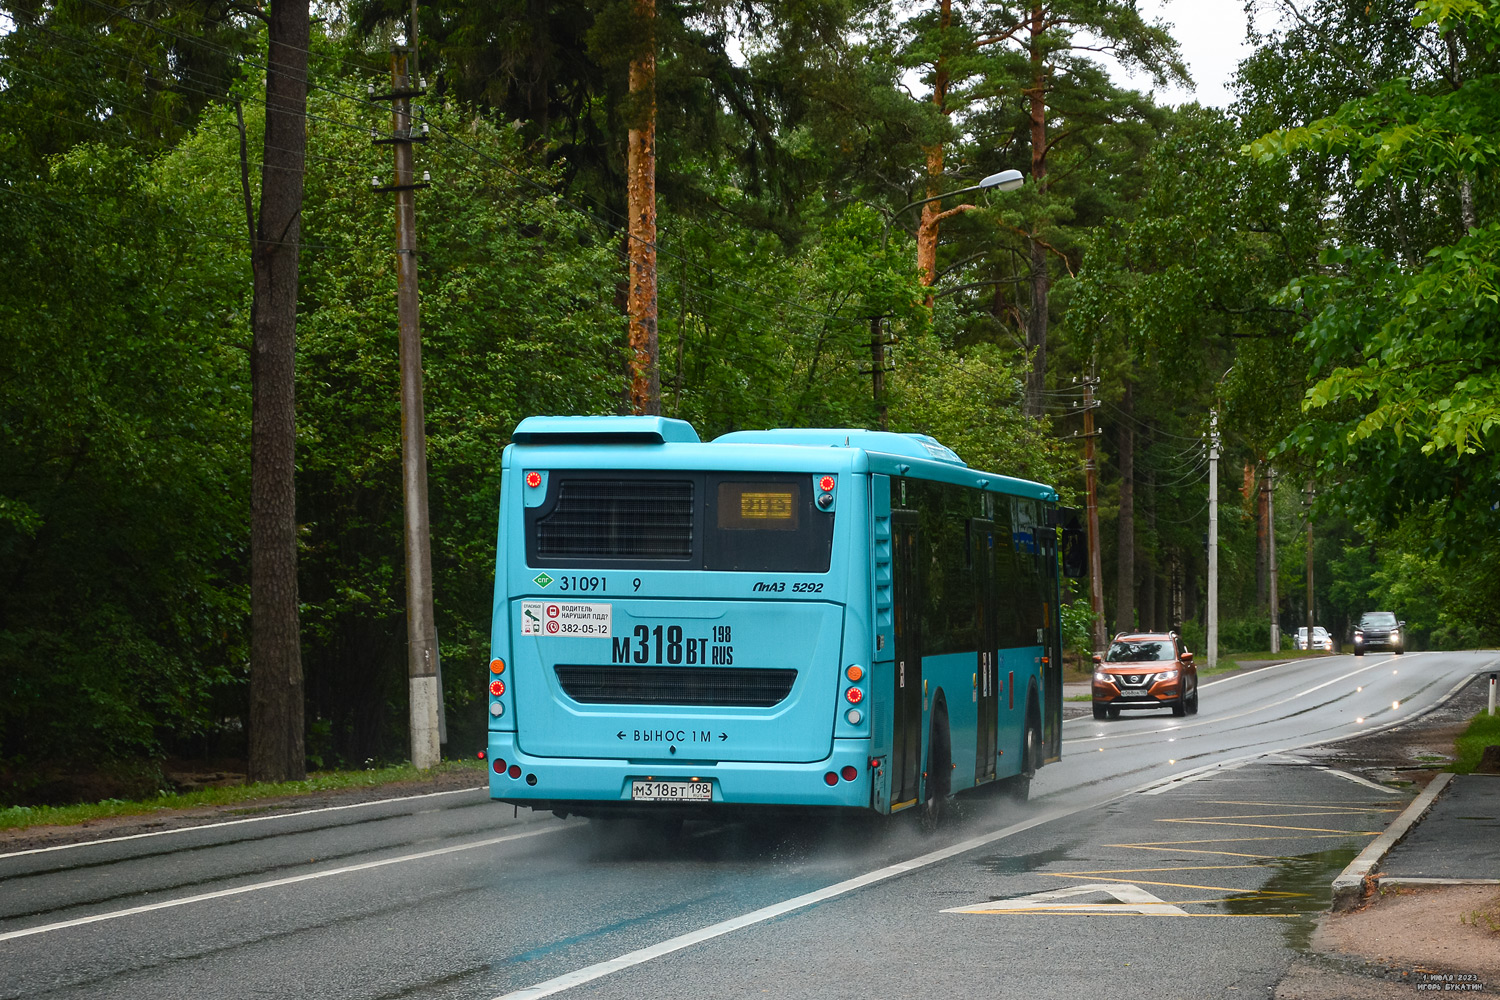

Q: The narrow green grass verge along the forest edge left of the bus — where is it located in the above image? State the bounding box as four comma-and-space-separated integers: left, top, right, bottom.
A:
0, 760, 485, 831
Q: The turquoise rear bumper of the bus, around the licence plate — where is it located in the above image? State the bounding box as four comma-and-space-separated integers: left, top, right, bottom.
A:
489, 732, 875, 814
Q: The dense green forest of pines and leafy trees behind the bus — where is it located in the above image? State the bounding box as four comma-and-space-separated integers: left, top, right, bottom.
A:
0, 0, 1500, 805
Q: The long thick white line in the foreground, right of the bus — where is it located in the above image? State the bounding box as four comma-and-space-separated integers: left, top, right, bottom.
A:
495, 804, 1097, 1000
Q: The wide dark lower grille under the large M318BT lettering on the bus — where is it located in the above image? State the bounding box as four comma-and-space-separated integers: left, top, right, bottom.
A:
557, 666, 797, 708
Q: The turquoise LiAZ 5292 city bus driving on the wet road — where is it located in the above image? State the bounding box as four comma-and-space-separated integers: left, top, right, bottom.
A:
488, 417, 1062, 819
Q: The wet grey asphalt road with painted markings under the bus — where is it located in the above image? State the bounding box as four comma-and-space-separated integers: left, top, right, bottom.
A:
0, 654, 1496, 1000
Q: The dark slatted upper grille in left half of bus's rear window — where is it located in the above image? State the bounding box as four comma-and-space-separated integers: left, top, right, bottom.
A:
536, 478, 693, 559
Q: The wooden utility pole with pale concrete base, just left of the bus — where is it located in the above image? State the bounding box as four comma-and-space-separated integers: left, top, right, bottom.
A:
374, 46, 443, 771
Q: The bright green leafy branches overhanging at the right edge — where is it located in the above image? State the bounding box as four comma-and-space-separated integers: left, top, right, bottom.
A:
1245, 0, 1500, 643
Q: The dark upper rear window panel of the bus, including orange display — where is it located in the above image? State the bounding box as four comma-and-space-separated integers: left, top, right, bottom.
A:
525, 471, 834, 573
